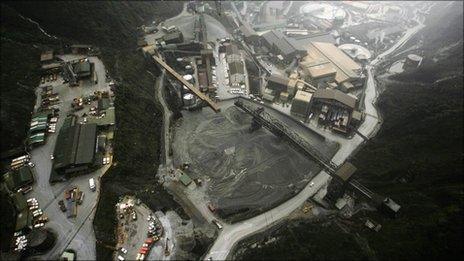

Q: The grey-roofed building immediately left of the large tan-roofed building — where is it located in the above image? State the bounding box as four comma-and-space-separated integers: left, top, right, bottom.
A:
261, 30, 307, 62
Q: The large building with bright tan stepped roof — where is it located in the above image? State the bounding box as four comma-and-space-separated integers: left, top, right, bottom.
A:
300, 42, 362, 91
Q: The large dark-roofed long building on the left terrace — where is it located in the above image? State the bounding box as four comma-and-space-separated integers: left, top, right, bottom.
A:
53, 117, 97, 175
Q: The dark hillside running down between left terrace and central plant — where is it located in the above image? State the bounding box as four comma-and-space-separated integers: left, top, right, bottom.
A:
2, 1, 187, 260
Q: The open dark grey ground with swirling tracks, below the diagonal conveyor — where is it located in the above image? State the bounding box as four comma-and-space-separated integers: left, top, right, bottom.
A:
173, 101, 337, 217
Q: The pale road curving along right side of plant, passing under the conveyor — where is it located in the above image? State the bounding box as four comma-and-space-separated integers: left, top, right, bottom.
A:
206, 5, 424, 260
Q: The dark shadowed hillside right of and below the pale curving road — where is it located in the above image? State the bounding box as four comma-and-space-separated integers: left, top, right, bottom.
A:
237, 3, 464, 260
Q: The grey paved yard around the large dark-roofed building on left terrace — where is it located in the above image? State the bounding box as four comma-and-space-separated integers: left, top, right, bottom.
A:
26, 55, 110, 260
